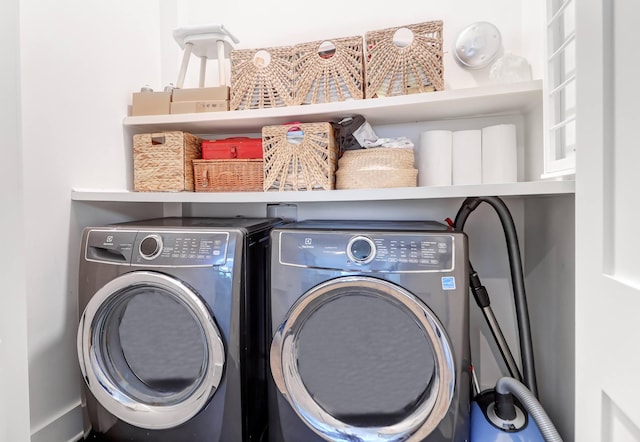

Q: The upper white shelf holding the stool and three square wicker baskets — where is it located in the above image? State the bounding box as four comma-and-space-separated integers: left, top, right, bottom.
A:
123, 80, 542, 134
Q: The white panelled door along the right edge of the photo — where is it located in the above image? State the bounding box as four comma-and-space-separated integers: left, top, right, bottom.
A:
575, 0, 640, 442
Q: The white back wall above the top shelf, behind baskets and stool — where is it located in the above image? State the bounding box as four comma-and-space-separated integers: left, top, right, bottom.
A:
159, 0, 544, 89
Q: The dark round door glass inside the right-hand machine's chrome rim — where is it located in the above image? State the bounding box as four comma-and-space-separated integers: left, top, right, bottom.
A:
297, 290, 435, 426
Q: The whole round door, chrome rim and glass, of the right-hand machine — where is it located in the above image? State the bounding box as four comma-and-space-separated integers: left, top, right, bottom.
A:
270, 276, 456, 441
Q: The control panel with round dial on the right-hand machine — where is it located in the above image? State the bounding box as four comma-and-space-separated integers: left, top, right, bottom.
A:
279, 231, 455, 272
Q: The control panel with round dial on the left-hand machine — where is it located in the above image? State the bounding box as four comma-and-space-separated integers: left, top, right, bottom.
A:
85, 229, 229, 267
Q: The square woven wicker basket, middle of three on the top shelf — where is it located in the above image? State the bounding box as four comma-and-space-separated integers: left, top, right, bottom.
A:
292, 36, 364, 104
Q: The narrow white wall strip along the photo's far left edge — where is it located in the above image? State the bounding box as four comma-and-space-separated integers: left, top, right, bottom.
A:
0, 0, 29, 442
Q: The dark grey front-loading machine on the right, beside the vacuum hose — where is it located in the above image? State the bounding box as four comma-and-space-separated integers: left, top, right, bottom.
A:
269, 220, 471, 442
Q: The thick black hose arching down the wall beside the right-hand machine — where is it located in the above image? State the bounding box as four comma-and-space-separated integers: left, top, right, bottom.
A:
454, 196, 538, 397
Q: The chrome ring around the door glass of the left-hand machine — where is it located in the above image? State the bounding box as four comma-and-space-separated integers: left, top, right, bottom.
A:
77, 271, 225, 429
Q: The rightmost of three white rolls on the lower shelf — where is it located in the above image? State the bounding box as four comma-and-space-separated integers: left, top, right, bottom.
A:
482, 124, 518, 184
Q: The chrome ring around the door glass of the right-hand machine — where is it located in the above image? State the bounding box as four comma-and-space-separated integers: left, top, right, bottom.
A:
270, 276, 455, 441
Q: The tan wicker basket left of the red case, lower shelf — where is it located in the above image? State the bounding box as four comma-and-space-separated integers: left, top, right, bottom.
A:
133, 132, 202, 192
